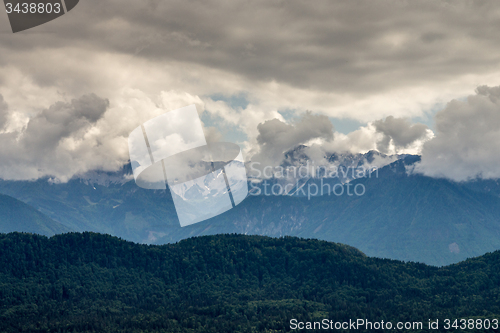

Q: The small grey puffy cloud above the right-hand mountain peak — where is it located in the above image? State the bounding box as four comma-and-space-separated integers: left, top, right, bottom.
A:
373, 116, 428, 153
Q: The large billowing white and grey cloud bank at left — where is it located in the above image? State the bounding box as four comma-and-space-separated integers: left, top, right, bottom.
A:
0, 89, 220, 182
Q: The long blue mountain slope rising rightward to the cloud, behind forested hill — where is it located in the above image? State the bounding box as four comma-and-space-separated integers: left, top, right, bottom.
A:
160, 156, 500, 265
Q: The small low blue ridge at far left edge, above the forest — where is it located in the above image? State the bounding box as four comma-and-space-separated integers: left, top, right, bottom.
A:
0, 194, 71, 236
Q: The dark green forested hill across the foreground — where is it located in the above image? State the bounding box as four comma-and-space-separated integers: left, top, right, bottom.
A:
0, 233, 500, 332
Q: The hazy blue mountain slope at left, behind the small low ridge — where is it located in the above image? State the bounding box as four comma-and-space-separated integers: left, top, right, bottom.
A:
0, 165, 180, 243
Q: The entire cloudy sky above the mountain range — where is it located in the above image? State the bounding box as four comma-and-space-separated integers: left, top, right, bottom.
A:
0, 0, 500, 181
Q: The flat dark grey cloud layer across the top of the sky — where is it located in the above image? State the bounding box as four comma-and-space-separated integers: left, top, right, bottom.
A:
0, 0, 500, 94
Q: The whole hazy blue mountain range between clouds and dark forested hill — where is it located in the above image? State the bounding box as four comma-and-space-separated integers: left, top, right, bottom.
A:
0, 156, 500, 265
